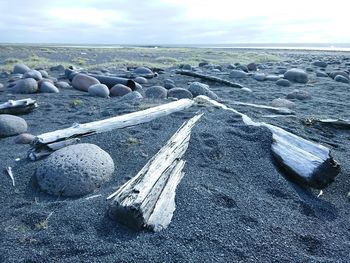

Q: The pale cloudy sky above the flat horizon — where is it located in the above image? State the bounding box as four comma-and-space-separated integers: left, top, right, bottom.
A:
0, 0, 350, 44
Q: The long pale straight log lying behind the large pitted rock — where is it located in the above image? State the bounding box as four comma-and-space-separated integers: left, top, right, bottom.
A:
28, 99, 194, 161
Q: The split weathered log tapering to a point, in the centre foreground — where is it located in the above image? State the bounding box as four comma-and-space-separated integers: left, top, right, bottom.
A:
107, 114, 203, 231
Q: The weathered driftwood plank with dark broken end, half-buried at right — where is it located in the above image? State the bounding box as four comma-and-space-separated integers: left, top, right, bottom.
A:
196, 96, 340, 189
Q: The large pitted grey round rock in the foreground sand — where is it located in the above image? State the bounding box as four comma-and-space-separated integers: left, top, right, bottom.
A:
36, 143, 114, 196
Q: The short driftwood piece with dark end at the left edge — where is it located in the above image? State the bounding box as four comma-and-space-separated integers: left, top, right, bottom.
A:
0, 99, 38, 114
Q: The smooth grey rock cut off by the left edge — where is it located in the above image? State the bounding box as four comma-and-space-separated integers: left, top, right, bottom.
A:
0, 114, 28, 138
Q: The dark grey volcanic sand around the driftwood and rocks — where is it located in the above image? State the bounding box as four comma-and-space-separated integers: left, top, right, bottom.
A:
0, 46, 350, 262
